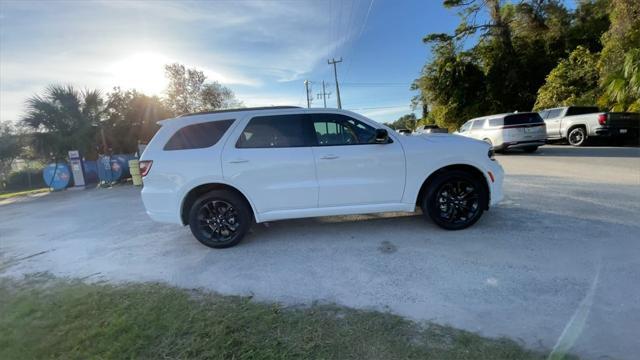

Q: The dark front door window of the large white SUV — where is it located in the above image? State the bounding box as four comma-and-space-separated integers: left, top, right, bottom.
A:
311, 114, 376, 146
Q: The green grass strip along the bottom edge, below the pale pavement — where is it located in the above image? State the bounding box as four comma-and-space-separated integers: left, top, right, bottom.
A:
0, 278, 544, 359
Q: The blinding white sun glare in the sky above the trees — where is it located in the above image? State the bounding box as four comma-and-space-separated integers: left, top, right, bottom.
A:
110, 52, 170, 95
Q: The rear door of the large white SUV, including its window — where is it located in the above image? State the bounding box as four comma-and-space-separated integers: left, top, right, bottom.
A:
222, 114, 318, 213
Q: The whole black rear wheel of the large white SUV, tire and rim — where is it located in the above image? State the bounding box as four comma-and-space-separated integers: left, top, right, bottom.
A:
189, 190, 252, 249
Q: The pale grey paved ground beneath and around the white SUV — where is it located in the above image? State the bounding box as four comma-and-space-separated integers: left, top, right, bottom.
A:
0, 146, 640, 359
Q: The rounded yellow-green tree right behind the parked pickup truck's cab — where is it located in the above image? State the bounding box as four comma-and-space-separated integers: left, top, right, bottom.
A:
534, 46, 598, 110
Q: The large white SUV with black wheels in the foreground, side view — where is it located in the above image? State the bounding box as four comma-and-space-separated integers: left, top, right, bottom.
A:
140, 107, 503, 248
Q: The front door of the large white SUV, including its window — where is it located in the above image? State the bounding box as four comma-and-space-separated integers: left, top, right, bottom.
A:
311, 113, 405, 207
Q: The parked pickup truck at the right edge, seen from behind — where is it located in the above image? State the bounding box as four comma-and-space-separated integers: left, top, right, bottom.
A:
540, 106, 640, 146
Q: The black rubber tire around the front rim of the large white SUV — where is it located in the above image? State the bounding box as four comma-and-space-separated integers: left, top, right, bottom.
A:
421, 170, 489, 230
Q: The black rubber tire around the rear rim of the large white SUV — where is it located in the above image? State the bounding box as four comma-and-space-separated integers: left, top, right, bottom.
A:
189, 190, 252, 249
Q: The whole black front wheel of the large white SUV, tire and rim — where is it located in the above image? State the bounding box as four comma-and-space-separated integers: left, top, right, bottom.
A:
421, 170, 489, 230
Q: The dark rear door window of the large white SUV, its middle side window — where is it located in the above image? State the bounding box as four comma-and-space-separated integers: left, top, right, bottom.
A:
236, 114, 310, 148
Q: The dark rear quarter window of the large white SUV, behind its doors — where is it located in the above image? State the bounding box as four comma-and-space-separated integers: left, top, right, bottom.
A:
164, 120, 233, 150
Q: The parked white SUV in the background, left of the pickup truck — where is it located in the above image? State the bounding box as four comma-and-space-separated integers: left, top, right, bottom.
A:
457, 112, 547, 152
